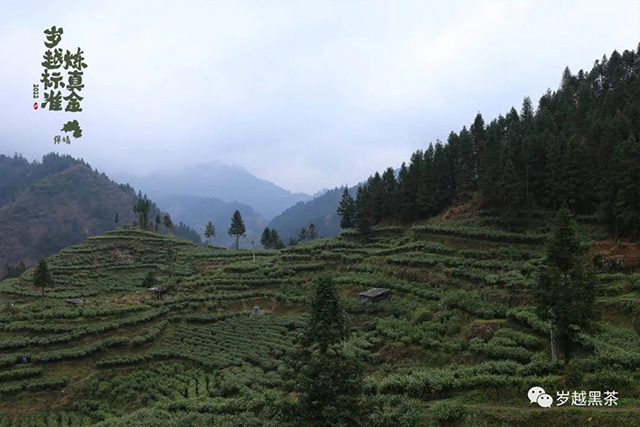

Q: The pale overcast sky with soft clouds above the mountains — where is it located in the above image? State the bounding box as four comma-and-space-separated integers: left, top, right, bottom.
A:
0, 0, 640, 193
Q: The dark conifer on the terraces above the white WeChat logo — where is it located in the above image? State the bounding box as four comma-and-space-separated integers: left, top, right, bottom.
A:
536, 208, 596, 362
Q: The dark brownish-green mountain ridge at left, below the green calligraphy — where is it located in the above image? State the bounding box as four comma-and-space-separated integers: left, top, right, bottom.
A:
0, 153, 199, 275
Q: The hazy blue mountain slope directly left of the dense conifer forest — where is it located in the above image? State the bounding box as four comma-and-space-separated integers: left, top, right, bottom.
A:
269, 186, 358, 243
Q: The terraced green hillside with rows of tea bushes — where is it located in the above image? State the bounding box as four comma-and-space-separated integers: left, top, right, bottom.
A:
0, 216, 640, 426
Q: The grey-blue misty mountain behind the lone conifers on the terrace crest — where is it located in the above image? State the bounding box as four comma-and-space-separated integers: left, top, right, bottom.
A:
156, 195, 267, 248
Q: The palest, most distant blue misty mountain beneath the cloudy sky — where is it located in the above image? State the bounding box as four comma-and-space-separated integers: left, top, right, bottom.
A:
121, 163, 311, 219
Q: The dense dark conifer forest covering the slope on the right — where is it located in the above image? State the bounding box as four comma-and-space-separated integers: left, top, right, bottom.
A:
350, 46, 640, 240
